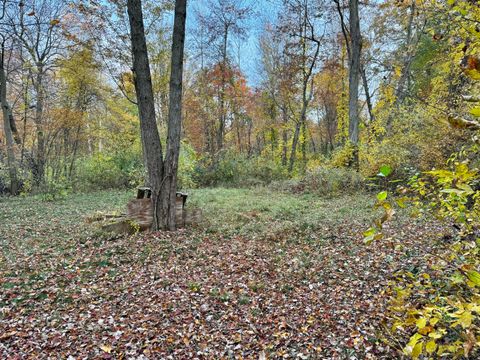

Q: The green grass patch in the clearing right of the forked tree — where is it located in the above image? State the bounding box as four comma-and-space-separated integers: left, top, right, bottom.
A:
188, 188, 373, 236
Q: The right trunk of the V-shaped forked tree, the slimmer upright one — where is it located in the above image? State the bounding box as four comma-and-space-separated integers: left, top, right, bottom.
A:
161, 0, 187, 230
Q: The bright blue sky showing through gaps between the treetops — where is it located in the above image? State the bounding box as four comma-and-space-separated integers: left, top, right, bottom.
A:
186, 0, 281, 86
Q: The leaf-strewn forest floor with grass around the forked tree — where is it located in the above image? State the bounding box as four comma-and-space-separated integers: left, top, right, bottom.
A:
0, 189, 448, 359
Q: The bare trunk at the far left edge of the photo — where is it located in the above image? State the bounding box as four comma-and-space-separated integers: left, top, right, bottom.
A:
0, 47, 19, 195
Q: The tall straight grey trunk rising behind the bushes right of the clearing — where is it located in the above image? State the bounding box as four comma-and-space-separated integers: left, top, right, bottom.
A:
348, 0, 362, 170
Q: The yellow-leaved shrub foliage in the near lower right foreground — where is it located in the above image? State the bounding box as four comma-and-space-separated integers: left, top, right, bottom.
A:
364, 155, 480, 359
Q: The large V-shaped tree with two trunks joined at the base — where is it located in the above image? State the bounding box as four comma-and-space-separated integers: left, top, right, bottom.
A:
127, 0, 186, 230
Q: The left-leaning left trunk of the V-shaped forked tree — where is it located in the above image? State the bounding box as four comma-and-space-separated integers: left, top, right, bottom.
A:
127, 0, 166, 230
